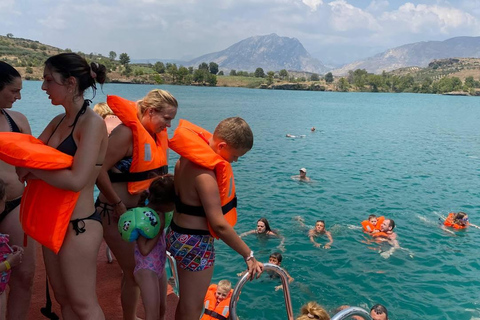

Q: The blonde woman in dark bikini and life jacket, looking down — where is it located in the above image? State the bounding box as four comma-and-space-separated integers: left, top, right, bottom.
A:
95, 89, 178, 320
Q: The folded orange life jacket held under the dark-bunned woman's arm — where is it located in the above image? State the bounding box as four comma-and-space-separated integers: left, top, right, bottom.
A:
0, 132, 80, 253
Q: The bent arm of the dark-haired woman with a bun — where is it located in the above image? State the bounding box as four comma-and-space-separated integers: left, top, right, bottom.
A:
20, 114, 106, 192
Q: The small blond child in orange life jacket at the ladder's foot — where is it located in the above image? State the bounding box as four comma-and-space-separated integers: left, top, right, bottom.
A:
200, 280, 233, 320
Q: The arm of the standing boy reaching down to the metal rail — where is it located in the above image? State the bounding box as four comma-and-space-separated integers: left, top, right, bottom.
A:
195, 170, 263, 280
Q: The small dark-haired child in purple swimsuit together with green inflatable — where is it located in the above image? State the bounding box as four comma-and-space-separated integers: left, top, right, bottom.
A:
118, 174, 175, 319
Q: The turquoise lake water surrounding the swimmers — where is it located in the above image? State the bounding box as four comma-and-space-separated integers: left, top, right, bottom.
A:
14, 81, 480, 320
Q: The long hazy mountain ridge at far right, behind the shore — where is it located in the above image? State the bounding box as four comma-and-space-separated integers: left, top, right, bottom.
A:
332, 37, 480, 76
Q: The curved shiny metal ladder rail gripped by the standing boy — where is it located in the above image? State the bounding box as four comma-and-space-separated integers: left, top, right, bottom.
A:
229, 263, 292, 320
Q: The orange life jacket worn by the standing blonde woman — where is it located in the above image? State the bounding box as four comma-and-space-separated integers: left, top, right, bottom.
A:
107, 96, 168, 194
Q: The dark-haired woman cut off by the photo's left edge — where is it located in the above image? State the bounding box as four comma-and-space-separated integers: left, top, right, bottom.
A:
0, 61, 36, 320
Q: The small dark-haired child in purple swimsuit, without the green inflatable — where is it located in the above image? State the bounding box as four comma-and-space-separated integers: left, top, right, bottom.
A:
133, 174, 175, 320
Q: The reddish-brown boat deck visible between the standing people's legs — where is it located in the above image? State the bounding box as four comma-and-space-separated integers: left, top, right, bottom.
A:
28, 243, 178, 320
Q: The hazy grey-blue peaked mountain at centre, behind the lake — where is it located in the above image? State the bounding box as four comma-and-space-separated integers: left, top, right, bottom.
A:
188, 33, 327, 74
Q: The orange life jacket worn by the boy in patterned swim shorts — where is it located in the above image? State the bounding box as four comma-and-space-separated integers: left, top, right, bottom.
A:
168, 119, 237, 239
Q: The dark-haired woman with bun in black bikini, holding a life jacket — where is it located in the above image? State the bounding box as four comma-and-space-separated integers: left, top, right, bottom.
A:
19, 53, 108, 319
